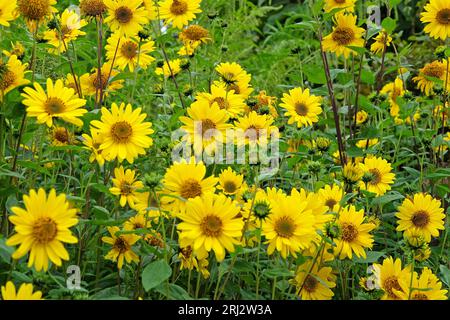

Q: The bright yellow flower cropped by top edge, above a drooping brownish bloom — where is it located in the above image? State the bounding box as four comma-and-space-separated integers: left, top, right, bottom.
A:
159, 0, 202, 29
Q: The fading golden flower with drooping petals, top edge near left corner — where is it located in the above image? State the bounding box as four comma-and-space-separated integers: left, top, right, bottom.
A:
17, 0, 58, 32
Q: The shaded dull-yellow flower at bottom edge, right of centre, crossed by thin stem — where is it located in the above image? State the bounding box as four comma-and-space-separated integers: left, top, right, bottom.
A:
293, 260, 336, 300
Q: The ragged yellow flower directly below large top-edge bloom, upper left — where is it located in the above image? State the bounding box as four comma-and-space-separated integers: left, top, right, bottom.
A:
105, 32, 155, 72
